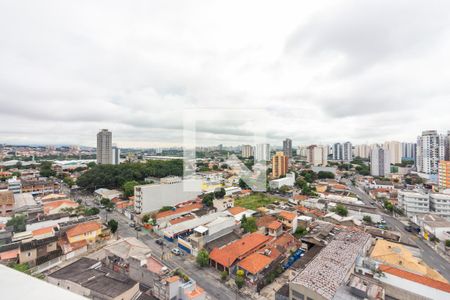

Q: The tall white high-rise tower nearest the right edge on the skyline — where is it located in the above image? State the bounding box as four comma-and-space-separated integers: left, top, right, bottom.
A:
416, 130, 446, 174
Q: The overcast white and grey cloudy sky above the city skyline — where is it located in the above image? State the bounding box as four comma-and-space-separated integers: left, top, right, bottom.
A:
0, 0, 450, 147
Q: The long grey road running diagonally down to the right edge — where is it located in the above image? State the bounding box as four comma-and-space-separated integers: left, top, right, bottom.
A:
348, 184, 450, 282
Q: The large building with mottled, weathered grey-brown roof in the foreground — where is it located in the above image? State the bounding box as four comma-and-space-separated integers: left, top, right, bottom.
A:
289, 231, 371, 300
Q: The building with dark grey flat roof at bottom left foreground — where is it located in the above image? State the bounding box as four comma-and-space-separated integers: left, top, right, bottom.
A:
47, 257, 139, 300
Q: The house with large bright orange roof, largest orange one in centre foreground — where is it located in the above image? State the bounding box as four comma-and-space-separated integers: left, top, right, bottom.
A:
209, 232, 272, 271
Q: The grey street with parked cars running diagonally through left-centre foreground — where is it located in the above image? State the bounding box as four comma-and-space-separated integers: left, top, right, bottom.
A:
101, 210, 244, 299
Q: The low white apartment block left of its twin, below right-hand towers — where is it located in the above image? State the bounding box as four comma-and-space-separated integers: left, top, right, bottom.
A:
398, 191, 430, 216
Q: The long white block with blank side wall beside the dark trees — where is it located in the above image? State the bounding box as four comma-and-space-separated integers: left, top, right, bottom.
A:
134, 179, 201, 214
